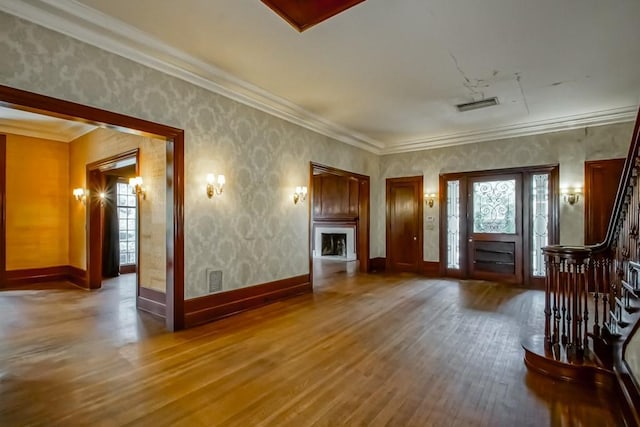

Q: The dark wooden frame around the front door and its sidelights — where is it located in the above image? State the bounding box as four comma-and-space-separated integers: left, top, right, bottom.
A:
439, 163, 560, 288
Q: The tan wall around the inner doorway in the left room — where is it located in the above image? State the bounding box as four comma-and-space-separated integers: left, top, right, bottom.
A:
69, 128, 166, 292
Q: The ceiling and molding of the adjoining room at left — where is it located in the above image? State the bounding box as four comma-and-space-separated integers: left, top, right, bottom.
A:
0, 106, 97, 142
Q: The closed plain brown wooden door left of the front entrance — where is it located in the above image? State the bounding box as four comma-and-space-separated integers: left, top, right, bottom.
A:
386, 176, 423, 272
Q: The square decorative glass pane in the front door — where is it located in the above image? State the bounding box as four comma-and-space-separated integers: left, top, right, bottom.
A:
473, 179, 516, 234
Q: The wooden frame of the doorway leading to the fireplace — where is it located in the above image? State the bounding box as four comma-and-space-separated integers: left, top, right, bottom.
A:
307, 162, 371, 285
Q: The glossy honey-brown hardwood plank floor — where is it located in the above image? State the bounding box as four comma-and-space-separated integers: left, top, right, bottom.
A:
0, 271, 623, 426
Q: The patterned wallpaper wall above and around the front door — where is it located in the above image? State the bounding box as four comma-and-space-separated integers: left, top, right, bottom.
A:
378, 123, 633, 261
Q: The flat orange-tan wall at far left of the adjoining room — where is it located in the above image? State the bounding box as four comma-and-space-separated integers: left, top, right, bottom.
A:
6, 135, 71, 270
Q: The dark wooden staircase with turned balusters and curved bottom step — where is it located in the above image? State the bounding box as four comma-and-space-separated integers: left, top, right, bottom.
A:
522, 112, 640, 425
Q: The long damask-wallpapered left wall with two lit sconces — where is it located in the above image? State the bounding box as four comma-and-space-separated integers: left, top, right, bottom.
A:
0, 13, 383, 298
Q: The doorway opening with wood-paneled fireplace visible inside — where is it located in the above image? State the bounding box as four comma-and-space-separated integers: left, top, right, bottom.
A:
309, 163, 370, 284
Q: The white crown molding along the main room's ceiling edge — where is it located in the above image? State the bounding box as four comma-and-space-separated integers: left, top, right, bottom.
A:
0, 0, 637, 155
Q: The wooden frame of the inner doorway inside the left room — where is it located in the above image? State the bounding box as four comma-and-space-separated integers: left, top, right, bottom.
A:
85, 148, 140, 290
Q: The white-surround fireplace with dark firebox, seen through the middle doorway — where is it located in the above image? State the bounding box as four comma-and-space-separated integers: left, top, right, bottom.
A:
313, 224, 357, 261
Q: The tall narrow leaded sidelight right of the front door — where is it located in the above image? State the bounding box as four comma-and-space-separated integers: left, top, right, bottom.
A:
531, 174, 549, 277
